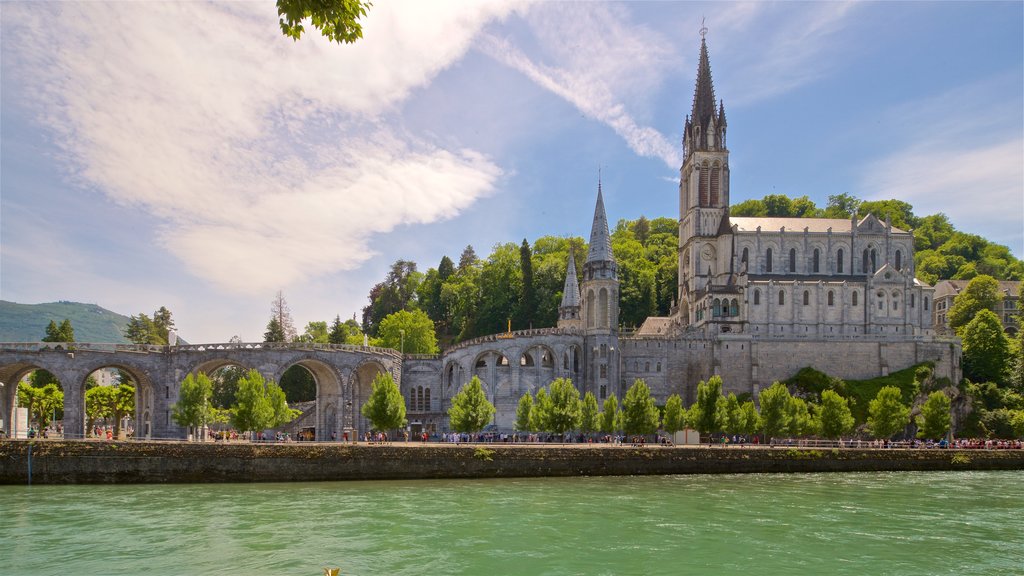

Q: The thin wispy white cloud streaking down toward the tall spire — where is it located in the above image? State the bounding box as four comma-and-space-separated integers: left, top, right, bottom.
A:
479, 3, 679, 168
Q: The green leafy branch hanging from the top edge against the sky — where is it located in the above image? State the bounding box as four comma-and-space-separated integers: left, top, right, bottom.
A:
278, 0, 373, 44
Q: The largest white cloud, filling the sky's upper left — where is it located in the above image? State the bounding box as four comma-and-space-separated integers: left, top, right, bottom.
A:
4, 2, 510, 293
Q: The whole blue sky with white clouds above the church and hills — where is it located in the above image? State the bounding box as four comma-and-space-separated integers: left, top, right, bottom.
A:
0, 0, 1024, 343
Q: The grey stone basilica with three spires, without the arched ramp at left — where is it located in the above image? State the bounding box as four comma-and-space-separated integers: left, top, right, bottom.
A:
401, 32, 961, 431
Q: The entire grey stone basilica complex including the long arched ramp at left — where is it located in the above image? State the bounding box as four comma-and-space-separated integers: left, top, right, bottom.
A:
0, 39, 961, 440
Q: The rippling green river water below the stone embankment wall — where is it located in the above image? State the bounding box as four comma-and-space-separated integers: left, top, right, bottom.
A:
0, 471, 1024, 576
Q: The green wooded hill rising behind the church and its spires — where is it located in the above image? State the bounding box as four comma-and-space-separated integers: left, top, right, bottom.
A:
362, 194, 1024, 347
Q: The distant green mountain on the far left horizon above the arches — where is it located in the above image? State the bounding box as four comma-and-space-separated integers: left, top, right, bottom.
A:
0, 300, 129, 344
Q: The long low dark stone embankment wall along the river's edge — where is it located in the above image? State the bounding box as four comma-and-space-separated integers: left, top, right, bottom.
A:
0, 441, 1024, 485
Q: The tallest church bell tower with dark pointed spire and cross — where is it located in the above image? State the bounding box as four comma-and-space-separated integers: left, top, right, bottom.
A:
679, 29, 732, 324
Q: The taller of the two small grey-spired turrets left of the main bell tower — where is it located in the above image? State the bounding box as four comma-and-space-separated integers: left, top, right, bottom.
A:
582, 180, 621, 402
